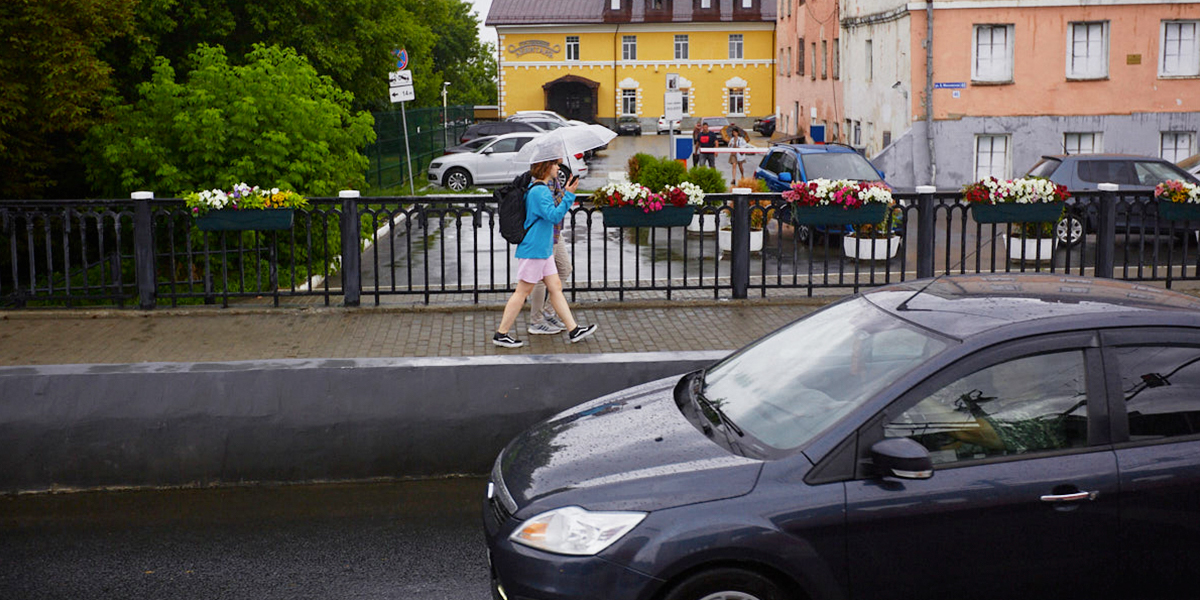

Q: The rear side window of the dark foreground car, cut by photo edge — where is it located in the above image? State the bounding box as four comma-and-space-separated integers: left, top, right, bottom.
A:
1115, 346, 1200, 440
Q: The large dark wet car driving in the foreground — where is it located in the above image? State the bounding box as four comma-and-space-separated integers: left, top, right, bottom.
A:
484, 274, 1200, 600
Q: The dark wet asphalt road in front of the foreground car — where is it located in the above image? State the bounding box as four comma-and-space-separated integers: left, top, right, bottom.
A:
0, 478, 491, 600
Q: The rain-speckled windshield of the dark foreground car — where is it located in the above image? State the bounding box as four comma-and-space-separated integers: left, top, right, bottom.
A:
704, 298, 947, 450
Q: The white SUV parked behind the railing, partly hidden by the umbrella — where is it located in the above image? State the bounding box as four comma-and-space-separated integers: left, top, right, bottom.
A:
428, 132, 588, 192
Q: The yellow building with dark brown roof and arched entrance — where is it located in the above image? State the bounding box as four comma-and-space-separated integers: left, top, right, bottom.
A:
486, 0, 775, 131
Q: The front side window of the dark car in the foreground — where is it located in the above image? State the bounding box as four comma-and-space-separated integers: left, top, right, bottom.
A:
884, 350, 1087, 464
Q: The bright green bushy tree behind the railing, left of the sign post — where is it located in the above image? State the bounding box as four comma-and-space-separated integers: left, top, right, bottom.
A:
88, 44, 374, 197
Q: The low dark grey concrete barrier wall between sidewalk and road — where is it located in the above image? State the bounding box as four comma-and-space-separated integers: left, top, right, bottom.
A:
0, 352, 725, 492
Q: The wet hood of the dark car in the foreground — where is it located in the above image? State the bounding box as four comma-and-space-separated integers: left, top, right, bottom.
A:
498, 378, 762, 515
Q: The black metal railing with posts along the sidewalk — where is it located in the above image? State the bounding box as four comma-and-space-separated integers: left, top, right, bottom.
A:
0, 187, 1200, 308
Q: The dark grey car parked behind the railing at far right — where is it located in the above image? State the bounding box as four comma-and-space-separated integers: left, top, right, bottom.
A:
1026, 154, 1200, 244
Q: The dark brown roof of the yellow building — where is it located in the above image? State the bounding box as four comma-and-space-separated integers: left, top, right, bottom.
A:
484, 0, 776, 26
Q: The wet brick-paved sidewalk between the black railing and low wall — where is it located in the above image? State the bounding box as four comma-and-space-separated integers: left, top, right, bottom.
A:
0, 298, 836, 366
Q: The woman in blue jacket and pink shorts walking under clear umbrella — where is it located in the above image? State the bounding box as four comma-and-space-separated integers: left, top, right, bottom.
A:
492, 158, 596, 348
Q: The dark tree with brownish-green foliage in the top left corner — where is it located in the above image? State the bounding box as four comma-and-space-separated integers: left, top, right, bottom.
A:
0, 0, 134, 198
